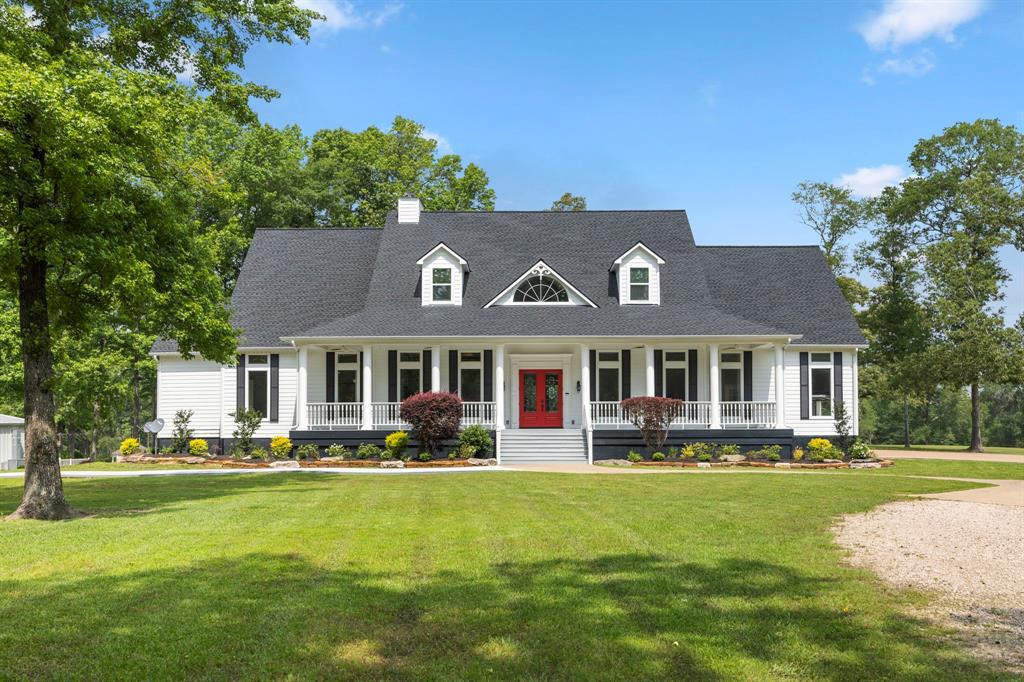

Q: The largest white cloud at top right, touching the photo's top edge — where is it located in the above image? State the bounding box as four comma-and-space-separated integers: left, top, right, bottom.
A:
858, 0, 985, 50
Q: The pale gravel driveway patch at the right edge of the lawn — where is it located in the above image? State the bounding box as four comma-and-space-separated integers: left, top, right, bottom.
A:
836, 500, 1024, 672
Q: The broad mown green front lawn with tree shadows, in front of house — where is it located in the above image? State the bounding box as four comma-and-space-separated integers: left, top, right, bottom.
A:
0, 472, 1010, 680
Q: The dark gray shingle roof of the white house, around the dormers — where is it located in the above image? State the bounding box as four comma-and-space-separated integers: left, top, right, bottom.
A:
155, 211, 864, 350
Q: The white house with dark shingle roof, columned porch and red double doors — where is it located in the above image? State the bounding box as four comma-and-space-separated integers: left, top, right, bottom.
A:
153, 199, 865, 462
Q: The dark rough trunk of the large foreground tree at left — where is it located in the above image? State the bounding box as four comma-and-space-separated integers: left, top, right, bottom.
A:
7, 243, 80, 520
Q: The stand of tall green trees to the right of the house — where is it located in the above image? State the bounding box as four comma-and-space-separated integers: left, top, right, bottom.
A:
793, 119, 1024, 452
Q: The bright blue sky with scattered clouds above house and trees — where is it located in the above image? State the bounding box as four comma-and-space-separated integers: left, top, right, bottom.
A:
247, 0, 1024, 318
